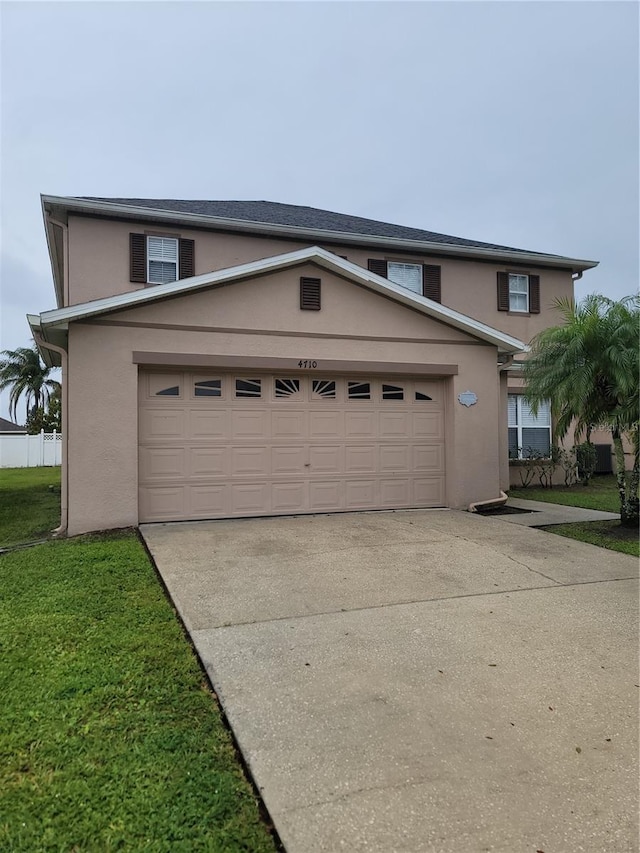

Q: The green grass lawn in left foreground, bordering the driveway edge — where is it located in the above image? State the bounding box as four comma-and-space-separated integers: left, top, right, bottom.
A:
0, 469, 277, 853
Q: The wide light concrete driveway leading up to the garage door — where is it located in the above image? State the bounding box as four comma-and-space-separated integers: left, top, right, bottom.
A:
141, 511, 640, 853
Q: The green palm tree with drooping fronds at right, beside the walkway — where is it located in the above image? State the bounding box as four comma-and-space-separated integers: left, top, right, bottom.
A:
523, 294, 640, 526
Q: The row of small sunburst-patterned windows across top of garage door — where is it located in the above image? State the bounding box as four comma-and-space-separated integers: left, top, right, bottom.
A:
155, 377, 433, 402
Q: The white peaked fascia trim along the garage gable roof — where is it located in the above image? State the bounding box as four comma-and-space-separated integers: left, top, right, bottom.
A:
40, 246, 526, 352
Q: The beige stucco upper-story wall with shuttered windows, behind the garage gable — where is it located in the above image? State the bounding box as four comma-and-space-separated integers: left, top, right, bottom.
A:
69, 216, 573, 343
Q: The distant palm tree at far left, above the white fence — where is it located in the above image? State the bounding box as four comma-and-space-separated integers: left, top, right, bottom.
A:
0, 344, 60, 418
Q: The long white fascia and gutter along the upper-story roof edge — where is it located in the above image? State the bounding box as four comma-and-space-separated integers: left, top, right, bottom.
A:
42, 195, 599, 271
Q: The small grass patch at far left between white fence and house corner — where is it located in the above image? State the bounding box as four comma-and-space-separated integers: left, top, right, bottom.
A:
0, 466, 60, 548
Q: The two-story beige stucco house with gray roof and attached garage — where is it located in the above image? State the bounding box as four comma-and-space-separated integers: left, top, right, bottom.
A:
29, 196, 595, 534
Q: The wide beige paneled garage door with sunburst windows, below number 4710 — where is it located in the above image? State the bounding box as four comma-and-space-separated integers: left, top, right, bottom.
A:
139, 371, 445, 521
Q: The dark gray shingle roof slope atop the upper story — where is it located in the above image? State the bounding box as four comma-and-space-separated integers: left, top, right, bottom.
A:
81, 196, 555, 257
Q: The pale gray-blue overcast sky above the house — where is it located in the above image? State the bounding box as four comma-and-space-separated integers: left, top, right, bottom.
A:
0, 0, 639, 417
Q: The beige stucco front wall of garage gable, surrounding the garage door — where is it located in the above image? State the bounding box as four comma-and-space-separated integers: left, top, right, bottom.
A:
68, 265, 502, 535
